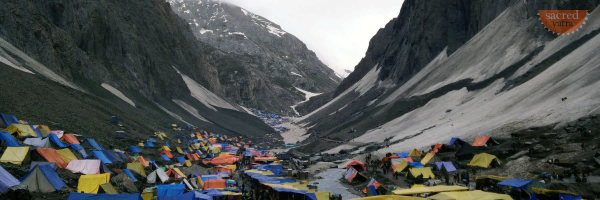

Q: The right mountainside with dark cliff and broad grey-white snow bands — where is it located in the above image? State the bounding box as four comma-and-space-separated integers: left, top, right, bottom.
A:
296, 0, 600, 153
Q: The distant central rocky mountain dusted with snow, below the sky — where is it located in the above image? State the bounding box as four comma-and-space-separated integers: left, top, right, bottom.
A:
168, 0, 342, 111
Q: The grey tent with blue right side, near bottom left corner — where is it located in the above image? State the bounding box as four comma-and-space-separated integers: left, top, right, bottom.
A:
19, 165, 66, 193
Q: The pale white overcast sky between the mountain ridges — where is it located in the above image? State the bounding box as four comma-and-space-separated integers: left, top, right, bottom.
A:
222, 0, 404, 75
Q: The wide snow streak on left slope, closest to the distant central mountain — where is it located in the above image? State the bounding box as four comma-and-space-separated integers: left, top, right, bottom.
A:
173, 67, 238, 111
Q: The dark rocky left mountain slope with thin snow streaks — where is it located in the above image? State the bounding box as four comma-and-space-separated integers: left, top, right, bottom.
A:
0, 0, 273, 141
